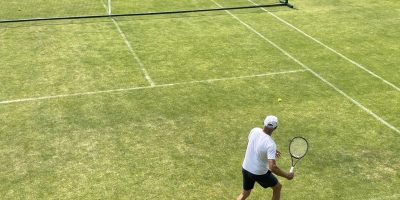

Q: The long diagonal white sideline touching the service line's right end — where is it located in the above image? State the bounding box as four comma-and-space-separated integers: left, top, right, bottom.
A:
210, 0, 400, 133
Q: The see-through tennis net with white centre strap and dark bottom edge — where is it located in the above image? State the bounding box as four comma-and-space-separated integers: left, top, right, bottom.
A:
0, 0, 290, 23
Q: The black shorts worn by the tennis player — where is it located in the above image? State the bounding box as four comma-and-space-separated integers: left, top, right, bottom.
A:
242, 168, 278, 190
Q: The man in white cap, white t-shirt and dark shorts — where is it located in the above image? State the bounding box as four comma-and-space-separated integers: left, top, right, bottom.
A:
237, 115, 294, 200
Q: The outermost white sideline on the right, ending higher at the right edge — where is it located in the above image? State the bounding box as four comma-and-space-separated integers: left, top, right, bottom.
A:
248, 0, 400, 92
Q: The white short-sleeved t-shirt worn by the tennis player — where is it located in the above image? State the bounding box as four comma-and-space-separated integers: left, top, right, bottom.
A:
242, 128, 276, 175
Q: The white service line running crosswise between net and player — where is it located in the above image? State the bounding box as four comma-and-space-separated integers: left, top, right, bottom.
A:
0, 69, 306, 105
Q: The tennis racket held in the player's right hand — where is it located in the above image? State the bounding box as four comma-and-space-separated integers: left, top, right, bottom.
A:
289, 137, 308, 173
